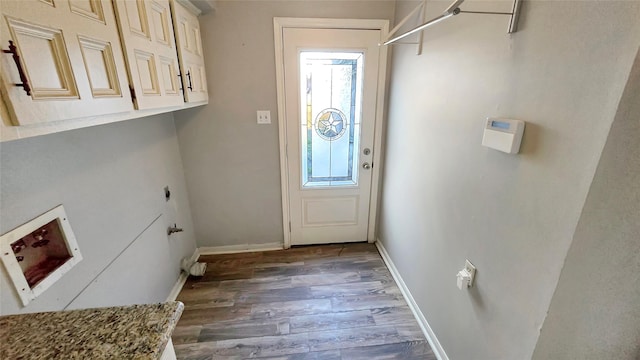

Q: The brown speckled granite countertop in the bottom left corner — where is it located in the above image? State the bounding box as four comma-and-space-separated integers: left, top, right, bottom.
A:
0, 301, 184, 360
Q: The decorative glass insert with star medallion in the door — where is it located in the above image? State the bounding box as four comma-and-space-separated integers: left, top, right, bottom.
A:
300, 51, 364, 187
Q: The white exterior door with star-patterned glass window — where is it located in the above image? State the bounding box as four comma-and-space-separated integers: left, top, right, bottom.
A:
282, 28, 380, 245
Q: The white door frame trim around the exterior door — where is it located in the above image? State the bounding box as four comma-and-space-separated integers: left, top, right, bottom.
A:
273, 17, 389, 249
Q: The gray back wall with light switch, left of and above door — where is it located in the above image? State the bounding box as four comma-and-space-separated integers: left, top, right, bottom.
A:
176, 1, 394, 246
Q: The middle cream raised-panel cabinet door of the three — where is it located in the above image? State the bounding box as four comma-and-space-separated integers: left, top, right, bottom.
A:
114, 0, 184, 109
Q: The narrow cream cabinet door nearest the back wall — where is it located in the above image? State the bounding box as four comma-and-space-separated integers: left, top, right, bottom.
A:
170, 0, 209, 103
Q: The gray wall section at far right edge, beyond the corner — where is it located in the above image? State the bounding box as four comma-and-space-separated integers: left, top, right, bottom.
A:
533, 47, 640, 360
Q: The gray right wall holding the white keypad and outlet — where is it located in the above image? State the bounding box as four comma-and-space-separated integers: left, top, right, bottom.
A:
380, 1, 640, 360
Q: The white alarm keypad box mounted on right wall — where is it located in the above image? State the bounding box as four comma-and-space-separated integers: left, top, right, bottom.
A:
482, 118, 524, 154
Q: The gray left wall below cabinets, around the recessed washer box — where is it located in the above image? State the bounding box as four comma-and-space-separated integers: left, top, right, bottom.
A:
0, 114, 195, 314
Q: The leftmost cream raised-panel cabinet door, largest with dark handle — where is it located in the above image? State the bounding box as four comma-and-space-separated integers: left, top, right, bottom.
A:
0, 0, 133, 125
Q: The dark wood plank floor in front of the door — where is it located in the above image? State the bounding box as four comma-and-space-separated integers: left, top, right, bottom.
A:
173, 244, 436, 360
